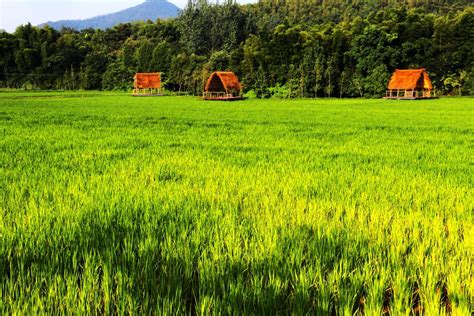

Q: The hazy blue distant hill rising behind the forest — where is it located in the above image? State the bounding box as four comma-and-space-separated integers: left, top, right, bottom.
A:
40, 0, 180, 30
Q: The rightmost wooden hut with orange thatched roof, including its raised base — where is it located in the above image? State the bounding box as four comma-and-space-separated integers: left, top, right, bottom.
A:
385, 68, 435, 100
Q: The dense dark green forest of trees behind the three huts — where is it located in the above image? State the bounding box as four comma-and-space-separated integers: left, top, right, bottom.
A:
0, 0, 474, 97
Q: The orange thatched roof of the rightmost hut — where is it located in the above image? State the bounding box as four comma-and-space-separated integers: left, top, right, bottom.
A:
388, 68, 433, 90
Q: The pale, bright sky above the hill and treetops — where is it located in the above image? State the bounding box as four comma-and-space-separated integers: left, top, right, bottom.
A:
0, 0, 255, 32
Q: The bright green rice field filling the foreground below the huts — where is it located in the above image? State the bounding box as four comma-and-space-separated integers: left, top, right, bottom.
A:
0, 92, 474, 315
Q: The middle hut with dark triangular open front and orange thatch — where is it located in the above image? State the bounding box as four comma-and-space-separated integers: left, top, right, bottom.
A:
202, 71, 242, 101
